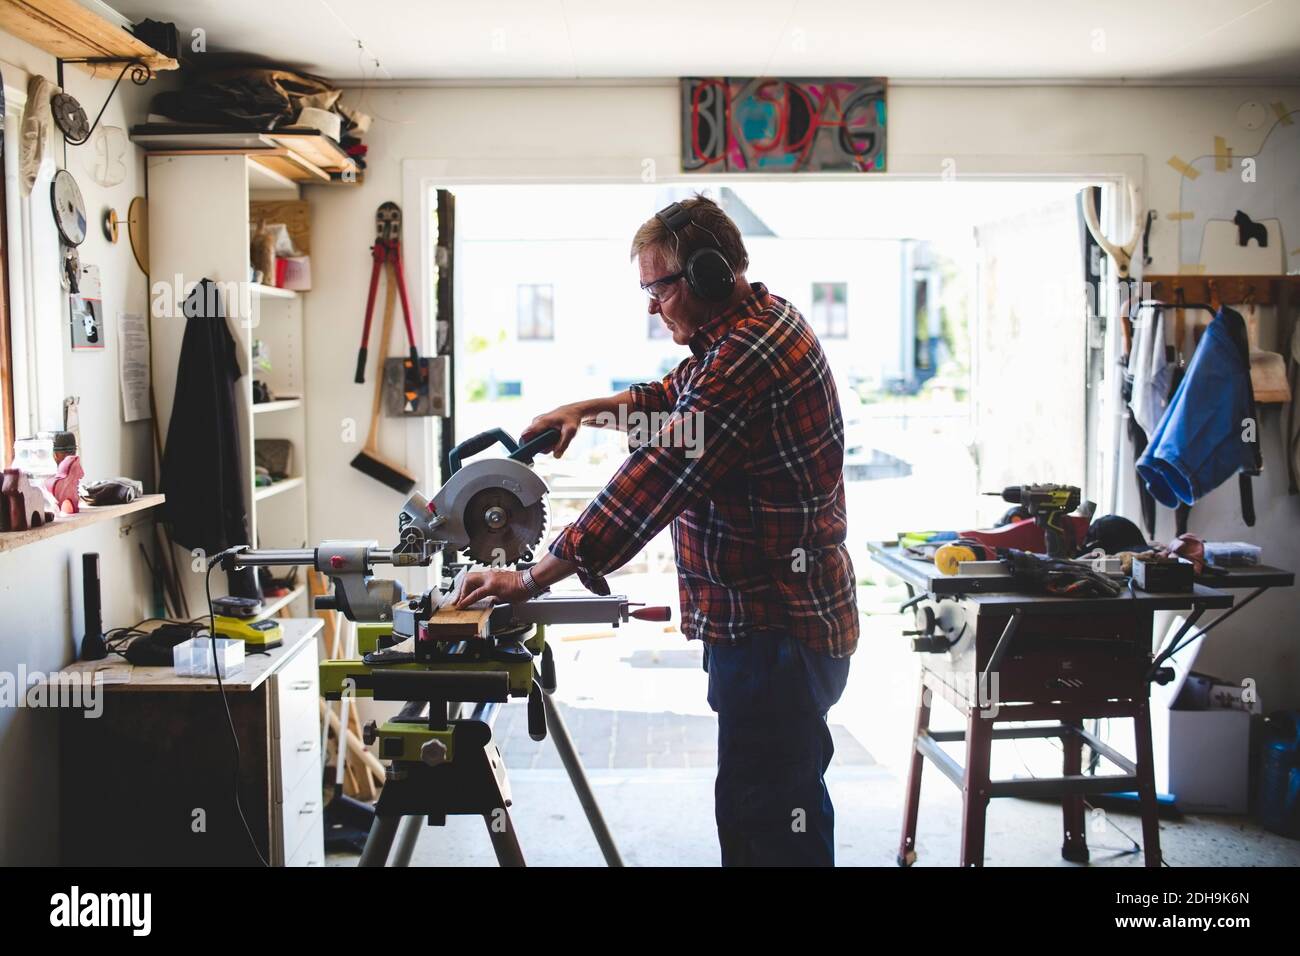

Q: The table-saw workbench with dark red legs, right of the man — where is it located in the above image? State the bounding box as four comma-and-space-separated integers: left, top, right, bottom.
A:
868, 544, 1295, 866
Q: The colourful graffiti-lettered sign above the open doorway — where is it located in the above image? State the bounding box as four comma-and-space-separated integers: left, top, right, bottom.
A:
681, 77, 885, 173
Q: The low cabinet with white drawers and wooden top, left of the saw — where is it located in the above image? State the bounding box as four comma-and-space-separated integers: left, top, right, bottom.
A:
60, 618, 325, 866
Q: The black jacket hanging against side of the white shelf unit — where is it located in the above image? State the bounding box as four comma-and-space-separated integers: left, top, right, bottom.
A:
160, 278, 252, 555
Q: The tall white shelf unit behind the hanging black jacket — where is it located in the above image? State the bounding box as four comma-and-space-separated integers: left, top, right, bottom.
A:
146, 152, 312, 617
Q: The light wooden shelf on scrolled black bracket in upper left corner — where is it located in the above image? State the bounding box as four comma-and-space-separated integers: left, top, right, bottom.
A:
0, 0, 178, 75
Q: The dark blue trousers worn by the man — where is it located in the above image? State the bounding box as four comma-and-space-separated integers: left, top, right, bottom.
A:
705, 631, 849, 866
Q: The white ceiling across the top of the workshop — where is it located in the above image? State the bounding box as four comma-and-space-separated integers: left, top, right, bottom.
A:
109, 0, 1300, 83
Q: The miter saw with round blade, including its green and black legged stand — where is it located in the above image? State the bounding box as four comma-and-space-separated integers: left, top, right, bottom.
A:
221, 428, 670, 866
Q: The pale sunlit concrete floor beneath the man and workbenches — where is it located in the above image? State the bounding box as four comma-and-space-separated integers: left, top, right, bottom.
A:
329, 580, 1300, 866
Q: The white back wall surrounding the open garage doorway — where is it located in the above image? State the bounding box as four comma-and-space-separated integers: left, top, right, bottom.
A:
307, 83, 1300, 708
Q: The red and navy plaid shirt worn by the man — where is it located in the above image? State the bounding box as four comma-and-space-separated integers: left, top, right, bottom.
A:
550, 282, 858, 657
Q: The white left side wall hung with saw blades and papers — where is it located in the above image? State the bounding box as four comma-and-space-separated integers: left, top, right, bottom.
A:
0, 33, 156, 865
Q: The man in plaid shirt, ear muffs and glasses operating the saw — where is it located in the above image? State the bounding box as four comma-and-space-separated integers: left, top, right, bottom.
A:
459, 196, 858, 866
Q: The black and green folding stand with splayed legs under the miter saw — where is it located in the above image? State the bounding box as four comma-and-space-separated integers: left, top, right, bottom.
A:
355, 624, 623, 866
